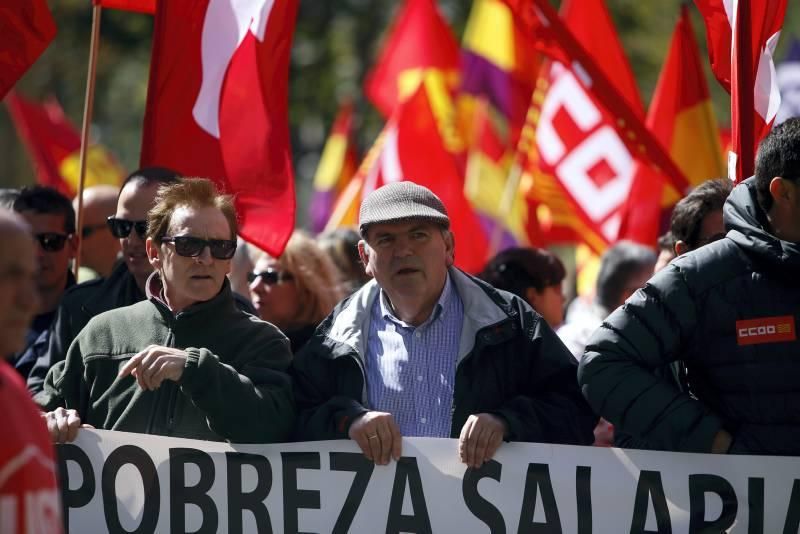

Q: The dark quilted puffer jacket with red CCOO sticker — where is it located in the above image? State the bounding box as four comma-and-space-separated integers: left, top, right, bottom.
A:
578, 178, 800, 455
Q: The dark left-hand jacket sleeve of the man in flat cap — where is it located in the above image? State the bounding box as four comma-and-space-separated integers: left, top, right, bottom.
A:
291, 337, 368, 441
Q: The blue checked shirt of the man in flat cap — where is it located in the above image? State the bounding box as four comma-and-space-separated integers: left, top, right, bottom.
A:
366, 274, 464, 438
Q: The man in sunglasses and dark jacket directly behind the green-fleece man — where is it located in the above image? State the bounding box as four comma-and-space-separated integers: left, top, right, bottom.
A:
28, 167, 179, 394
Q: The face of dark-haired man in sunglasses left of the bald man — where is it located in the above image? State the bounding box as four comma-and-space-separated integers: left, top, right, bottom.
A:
20, 211, 77, 291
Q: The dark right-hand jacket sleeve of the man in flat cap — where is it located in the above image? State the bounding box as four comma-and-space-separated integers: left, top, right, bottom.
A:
495, 307, 598, 445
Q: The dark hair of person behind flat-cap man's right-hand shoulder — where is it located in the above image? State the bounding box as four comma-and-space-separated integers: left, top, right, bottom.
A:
478, 247, 567, 301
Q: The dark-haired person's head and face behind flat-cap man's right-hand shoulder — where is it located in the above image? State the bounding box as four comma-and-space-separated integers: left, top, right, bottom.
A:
478, 247, 567, 329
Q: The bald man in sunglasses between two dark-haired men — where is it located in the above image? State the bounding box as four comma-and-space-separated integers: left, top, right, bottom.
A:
72, 185, 120, 282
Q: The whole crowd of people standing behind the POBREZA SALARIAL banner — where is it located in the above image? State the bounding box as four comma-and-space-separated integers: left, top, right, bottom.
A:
6, 119, 800, 524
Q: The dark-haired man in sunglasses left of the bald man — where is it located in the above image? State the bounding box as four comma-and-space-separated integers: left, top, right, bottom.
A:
12, 185, 78, 380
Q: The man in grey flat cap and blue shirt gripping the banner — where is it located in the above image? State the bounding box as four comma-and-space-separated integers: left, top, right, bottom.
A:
292, 182, 596, 467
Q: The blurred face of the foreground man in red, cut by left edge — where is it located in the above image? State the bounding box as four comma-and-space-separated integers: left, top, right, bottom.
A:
0, 229, 39, 358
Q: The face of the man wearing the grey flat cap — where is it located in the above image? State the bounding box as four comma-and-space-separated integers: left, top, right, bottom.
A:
359, 221, 454, 304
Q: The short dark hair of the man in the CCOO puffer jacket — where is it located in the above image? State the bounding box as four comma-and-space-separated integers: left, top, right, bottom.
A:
755, 118, 800, 213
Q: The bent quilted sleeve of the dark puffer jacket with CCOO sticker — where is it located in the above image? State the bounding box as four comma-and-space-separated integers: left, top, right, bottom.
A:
578, 265, 722, 452
